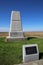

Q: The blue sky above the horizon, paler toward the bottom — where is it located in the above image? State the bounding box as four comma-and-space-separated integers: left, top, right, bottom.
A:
0, 0, 43, 32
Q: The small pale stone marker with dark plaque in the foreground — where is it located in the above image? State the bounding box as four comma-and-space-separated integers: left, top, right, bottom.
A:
23, 44, 39, 62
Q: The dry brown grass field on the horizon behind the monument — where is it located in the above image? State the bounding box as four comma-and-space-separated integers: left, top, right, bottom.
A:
0, 32, 43, 37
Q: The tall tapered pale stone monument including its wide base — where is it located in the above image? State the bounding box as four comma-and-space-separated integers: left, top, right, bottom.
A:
7, 11, 25, 41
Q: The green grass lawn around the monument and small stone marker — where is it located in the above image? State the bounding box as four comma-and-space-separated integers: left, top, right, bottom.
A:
0, 38, 43, 65
